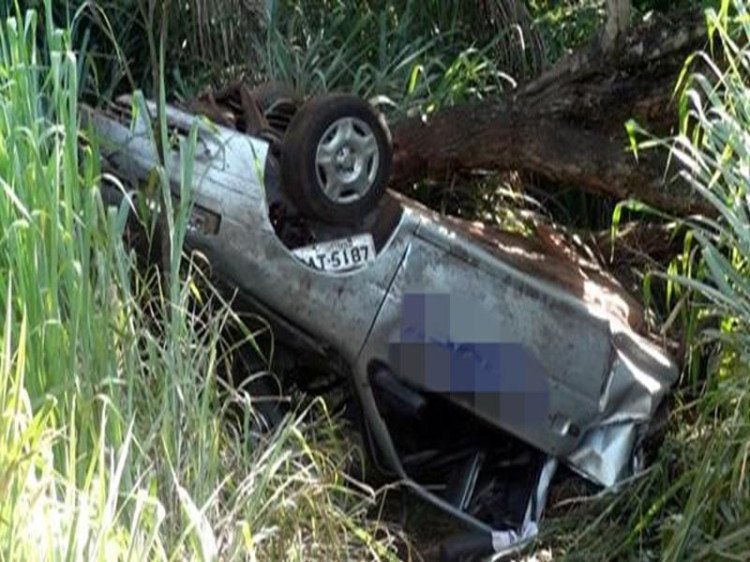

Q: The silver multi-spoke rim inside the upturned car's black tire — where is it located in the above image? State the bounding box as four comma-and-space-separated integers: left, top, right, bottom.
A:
315, 117, 380, 204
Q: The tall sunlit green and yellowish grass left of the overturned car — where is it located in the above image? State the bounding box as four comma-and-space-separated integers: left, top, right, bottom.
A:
0, 0, 402, 561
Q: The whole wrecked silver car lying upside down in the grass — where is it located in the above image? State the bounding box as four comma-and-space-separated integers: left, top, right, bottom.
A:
91, 92, 677, 558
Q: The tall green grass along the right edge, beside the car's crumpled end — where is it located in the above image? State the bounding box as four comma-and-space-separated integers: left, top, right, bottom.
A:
550, 0, 750, 561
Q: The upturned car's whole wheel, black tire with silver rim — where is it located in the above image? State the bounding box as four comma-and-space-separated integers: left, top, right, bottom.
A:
282, 94, 393, 224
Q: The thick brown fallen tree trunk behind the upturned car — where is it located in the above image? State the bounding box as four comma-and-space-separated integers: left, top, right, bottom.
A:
393, 11, 709, 215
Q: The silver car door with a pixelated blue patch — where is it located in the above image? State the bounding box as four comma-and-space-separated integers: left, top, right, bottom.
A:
361, 219, 612, 456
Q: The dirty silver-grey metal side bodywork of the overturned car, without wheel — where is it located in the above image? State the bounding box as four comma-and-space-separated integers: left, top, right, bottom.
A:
93, 100, 677, 552
